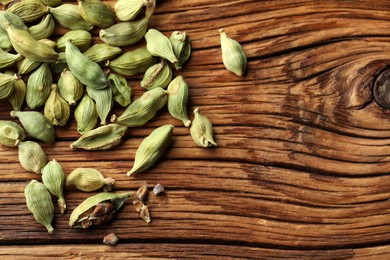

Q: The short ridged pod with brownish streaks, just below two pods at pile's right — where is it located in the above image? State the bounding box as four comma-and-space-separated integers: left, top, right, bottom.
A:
141, 59, 172, 90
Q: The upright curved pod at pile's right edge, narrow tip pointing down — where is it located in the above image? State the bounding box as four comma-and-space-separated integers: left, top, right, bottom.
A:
167, 76, 191, 127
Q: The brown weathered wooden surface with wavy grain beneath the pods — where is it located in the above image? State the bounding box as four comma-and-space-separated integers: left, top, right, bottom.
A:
0, 0, 390, 259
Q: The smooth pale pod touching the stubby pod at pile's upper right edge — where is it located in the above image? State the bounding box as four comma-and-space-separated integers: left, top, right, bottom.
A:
145, 29, 178, 64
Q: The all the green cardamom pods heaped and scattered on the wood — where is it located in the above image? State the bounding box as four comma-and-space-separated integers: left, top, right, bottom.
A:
0, 0, 247, 233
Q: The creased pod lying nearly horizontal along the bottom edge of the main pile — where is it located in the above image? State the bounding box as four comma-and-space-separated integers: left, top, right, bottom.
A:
70, 124, 127, 150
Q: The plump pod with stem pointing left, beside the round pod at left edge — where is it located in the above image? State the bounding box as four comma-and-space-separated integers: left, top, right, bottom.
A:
11, 111, 55, 144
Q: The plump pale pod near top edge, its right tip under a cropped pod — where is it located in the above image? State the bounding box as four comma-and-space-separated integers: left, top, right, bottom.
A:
49, 4, 93, 31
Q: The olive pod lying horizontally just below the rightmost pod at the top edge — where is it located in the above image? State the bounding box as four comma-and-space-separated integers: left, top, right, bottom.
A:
99, 17, 149, 46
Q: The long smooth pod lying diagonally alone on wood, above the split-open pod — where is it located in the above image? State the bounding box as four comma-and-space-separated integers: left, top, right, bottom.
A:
127, 125, 174, 176
